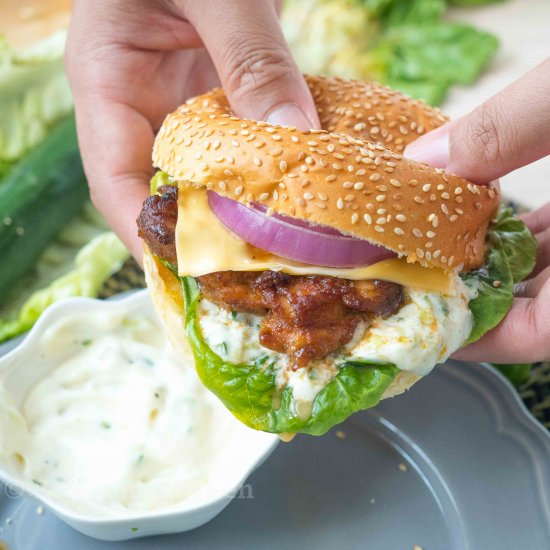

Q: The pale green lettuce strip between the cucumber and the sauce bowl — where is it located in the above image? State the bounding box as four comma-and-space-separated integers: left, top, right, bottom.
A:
0, 232, 130, 342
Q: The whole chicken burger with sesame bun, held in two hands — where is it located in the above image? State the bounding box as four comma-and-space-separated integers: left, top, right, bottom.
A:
137, 77, 536, 436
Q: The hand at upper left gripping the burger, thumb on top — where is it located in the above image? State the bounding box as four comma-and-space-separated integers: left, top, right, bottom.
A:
65, 0, 319, 261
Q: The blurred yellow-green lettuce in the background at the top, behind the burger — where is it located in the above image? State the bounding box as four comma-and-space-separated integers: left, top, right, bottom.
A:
282, 0, 504, 105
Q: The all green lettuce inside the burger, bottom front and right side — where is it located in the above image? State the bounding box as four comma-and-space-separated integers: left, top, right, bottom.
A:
154, 208, 536, 435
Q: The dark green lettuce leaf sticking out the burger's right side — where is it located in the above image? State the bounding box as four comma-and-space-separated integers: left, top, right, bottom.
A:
462, 207, 537, 344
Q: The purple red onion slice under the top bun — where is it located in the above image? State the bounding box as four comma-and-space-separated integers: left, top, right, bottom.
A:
208, 191, 396, 267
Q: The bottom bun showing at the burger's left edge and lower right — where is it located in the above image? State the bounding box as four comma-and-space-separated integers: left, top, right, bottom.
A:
143, 250, 421, 399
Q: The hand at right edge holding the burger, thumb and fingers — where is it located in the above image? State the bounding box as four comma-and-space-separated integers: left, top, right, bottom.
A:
404, 59, 550, 363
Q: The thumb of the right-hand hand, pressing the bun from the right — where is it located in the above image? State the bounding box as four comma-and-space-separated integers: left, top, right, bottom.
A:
405, 59, 550, 183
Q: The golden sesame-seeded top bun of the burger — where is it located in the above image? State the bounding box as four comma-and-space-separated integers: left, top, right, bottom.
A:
153, 77, 500, 271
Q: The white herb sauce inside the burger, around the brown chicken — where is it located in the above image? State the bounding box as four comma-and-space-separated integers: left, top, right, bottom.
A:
198, 276, 475, 409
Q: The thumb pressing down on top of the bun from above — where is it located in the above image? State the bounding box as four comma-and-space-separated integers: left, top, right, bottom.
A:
185, 0, 319, 130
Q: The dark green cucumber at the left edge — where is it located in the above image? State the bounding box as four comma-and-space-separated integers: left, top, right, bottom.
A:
0, 115, 88, 304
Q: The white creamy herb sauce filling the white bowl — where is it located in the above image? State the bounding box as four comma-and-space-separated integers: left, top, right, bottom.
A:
0, 306, 242, 515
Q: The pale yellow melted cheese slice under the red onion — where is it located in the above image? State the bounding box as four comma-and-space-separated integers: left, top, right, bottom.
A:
176, 186, 454, 294
